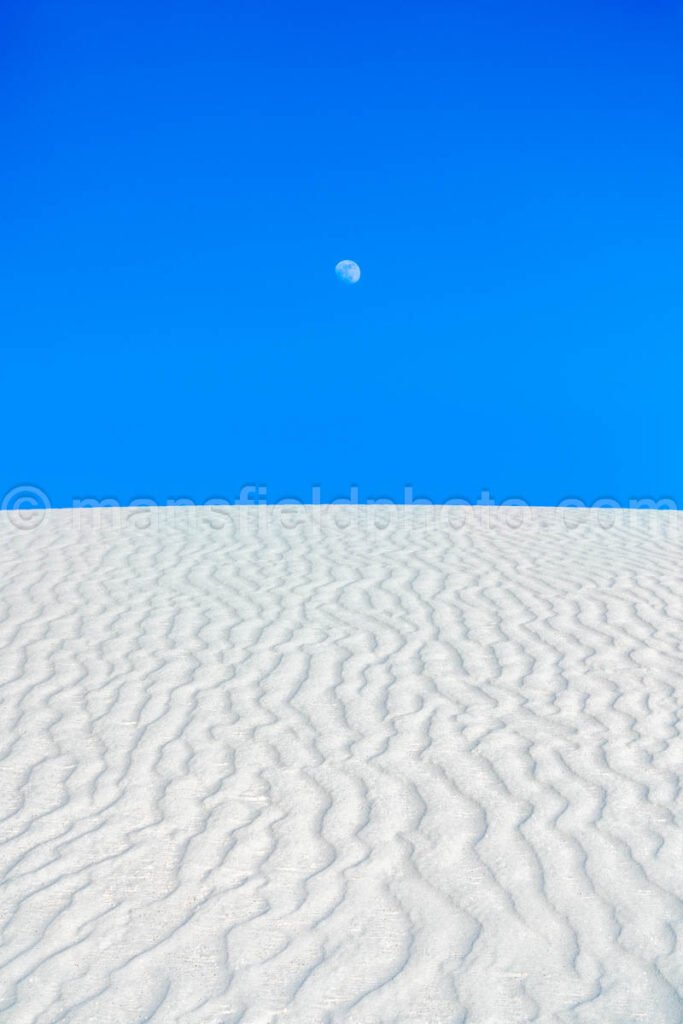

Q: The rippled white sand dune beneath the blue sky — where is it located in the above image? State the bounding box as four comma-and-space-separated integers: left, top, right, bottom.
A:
0, 508, 683, 1024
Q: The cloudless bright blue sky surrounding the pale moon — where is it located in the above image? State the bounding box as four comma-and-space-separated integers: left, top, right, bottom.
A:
0, 0, 683, 505
